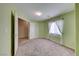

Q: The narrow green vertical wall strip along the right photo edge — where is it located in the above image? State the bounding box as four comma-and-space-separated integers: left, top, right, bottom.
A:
75, 3, 79, 56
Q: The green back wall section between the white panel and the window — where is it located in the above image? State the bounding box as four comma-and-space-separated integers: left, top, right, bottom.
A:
37, 21, 48, 37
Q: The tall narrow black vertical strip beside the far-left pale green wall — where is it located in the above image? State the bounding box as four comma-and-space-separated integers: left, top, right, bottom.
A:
11, 11, 15, 56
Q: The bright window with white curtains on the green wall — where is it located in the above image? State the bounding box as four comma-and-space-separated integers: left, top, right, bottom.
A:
49, 20, 63, 35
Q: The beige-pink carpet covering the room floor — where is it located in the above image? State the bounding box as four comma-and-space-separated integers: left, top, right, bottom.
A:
16, 39, 75, 56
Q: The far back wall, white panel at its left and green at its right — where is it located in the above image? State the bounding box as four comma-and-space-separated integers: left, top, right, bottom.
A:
30, 21, 48, 39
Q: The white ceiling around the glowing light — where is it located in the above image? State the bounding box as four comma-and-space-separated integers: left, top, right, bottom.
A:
15, 3, 74, 20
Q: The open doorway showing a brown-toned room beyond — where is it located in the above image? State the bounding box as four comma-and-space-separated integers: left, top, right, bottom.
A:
18, 18, 30, 45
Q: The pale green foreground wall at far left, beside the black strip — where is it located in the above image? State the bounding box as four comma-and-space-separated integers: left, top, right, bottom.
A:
0, 4, 11, 56
